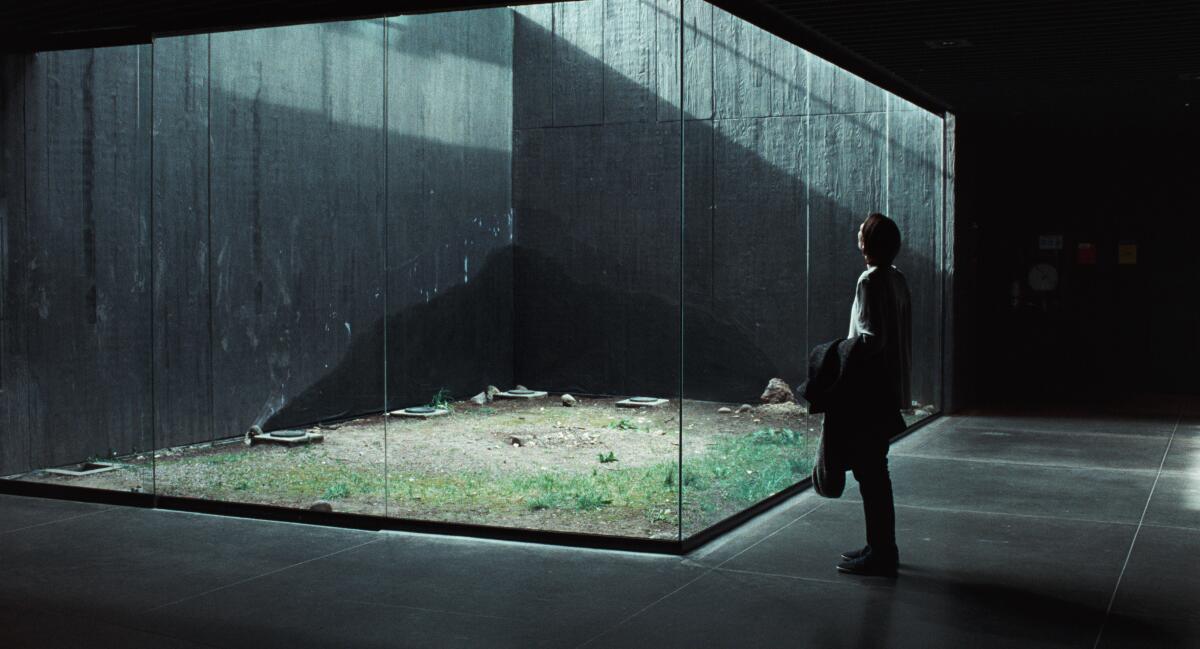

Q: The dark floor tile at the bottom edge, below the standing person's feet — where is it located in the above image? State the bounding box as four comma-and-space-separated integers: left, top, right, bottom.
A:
584, 563, 1104, 649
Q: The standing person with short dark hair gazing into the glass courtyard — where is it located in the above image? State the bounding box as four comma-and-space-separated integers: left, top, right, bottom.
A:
826, 212, 912, 577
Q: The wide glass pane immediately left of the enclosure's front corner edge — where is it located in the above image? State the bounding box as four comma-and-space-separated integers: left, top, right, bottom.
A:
388, 0, 680, 540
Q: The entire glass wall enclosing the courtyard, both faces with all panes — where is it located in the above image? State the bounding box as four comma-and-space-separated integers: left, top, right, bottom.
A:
0, 0, 943, 541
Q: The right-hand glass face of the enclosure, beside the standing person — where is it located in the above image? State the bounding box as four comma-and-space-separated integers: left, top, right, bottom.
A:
682, 2, 942, 537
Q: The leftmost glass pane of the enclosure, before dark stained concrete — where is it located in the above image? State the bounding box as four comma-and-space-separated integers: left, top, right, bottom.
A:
0, 42, 154, 492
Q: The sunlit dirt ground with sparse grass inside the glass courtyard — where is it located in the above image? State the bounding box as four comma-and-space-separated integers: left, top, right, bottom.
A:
20, 396, 936, 539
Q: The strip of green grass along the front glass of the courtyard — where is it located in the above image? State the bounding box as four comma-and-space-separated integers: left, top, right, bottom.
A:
150, 420, 817, 529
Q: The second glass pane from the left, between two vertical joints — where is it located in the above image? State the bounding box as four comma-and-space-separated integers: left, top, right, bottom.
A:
144, 20, 385, 515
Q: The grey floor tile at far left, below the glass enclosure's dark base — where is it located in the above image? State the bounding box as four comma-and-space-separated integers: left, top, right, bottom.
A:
0, 507, 379, 621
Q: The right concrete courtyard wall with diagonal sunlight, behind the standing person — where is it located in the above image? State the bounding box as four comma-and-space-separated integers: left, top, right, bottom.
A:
514, 0, 942, 403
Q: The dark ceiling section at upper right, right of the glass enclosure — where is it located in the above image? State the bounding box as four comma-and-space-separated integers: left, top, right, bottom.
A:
742, 0, 1200, 113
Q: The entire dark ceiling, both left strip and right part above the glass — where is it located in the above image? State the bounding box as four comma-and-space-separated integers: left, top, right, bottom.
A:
0, 0, 1200, 116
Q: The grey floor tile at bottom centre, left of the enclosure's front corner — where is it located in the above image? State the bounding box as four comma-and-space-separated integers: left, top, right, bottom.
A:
137, 535, 703, 648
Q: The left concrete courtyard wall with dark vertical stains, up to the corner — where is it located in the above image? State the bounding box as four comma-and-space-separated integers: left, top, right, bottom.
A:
0, 10, 512, 474
